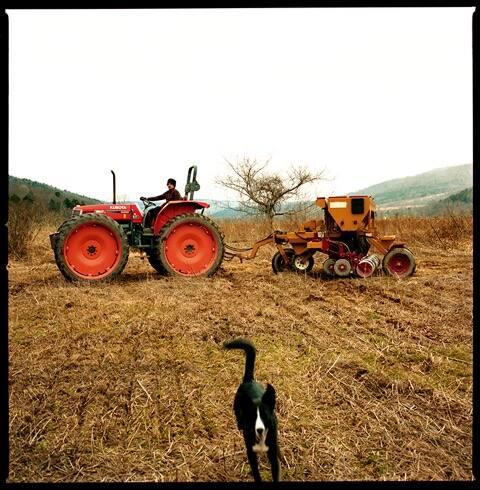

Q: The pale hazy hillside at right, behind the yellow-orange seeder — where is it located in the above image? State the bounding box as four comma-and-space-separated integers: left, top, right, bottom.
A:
350, 164, 473, 214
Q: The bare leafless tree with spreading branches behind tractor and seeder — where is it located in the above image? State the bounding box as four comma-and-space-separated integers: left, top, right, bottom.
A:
217, 158, 322, 229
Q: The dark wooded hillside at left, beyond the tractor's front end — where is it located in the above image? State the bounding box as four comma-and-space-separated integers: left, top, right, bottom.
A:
8, 175, 101, 211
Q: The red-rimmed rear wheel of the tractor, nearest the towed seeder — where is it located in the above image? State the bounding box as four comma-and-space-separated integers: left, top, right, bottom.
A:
158, 213, 224, 277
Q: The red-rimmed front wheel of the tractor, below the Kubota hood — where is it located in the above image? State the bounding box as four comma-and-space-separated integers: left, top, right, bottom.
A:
54, 213, 129, 281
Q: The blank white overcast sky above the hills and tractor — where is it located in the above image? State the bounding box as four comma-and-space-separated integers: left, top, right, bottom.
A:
7, 8, 474, 200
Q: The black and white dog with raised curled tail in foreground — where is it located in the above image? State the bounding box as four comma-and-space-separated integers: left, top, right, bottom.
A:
223, 339, 280, 483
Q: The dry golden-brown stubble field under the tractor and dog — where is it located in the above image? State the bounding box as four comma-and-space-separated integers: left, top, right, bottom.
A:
8, 216, 472, 482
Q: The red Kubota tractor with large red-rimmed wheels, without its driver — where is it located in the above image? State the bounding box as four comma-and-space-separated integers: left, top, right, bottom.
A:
50, 166, 224, 281
